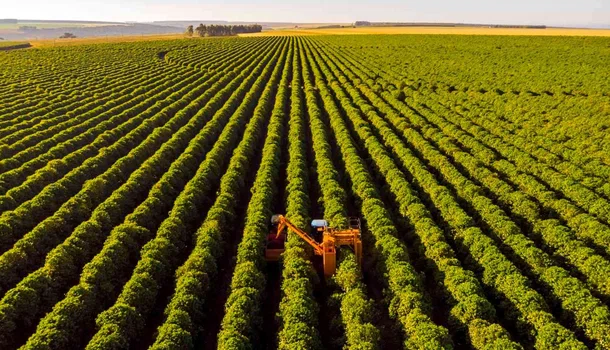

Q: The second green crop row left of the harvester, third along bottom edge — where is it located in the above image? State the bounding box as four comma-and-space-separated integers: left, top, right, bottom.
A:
152, 38, 287, 349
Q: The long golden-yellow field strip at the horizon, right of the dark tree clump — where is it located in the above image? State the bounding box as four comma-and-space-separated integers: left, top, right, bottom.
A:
242, 27, 610, 36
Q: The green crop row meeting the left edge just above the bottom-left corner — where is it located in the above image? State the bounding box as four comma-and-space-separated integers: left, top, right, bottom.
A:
0, 37, 280, 348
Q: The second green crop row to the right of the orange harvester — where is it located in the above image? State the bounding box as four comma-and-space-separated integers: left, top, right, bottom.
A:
304, 38, 520, 349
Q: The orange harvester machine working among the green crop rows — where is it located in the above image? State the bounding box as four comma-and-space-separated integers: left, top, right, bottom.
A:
265, 215, 362, 277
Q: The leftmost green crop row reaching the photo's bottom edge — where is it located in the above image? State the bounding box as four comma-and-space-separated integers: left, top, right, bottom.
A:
18, 36, 280, 348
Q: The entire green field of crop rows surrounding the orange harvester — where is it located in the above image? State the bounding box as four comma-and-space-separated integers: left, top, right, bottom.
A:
0, 35, 610, 350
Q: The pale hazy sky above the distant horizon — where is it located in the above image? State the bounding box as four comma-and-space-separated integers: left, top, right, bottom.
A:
0, 0, 610, 26
